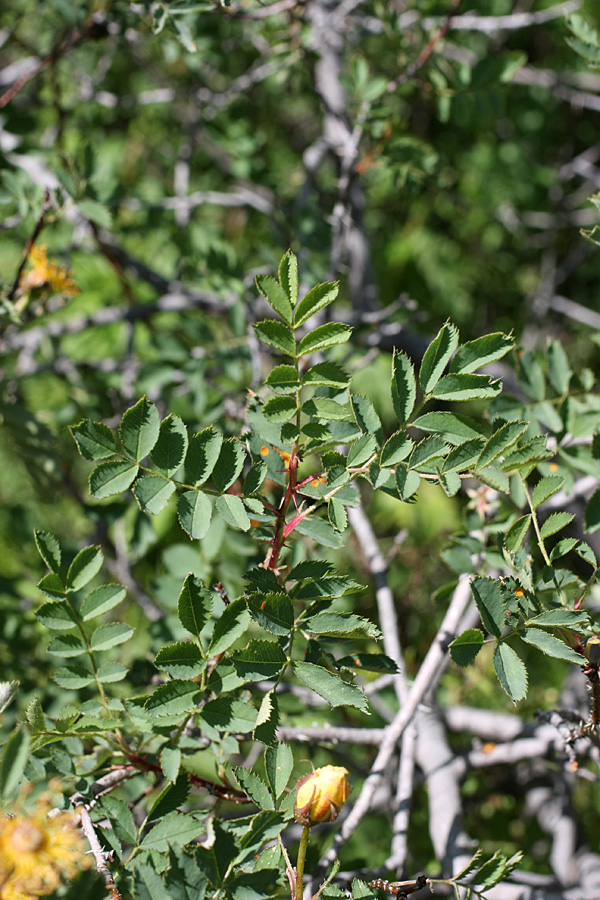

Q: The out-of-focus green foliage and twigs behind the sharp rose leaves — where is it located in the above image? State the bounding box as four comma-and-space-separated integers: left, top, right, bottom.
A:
0, 0, 600, 884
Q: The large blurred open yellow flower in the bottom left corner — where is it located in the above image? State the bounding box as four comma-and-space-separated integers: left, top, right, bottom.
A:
0, 798, 91, 900
